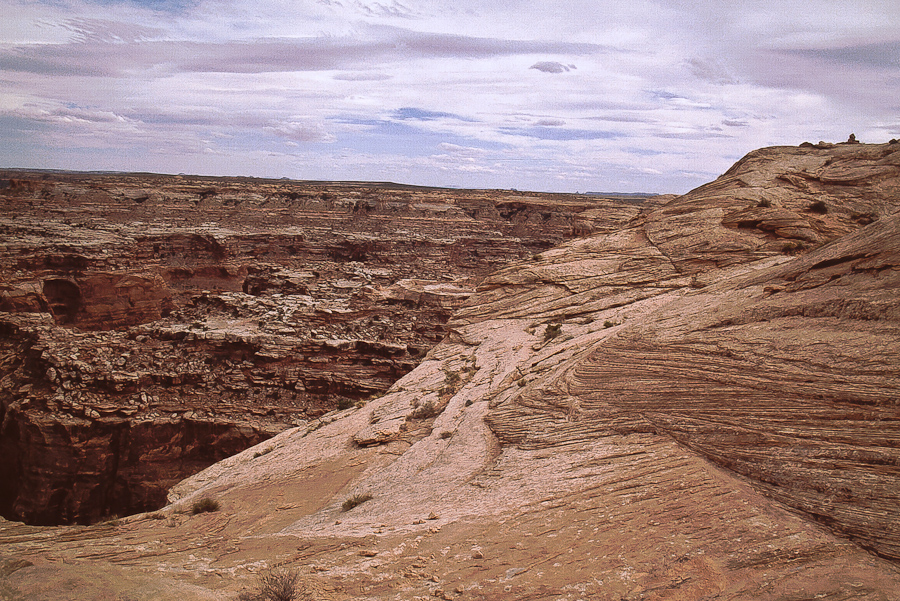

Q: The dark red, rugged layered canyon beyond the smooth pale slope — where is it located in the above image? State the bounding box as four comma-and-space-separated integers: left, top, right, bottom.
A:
0, 172, 640, 524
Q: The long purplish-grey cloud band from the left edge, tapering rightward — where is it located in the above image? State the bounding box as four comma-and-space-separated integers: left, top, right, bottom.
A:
0, 23, 609, 77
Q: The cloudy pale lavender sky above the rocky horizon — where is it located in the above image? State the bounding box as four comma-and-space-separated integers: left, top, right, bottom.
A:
0, 0, 900, 193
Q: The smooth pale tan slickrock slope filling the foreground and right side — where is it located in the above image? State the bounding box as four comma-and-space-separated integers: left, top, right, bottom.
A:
0, 144, 900, 601
